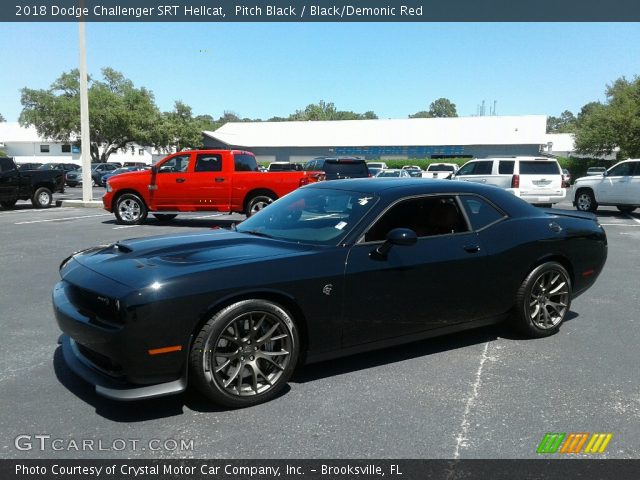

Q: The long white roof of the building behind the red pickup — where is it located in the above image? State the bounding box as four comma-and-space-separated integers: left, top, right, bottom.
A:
203, 115, 547, 147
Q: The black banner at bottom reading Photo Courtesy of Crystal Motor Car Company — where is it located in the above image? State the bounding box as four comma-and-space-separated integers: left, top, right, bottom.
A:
0, 458, 640, 480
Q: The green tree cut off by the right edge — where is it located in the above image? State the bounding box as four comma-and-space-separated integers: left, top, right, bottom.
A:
576, 76, 640, 158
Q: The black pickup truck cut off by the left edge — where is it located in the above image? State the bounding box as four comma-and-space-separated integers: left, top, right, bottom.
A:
0, 157, 64, 208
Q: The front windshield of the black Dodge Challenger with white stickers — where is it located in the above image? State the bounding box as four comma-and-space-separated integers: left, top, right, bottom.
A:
237, 188, 377, 245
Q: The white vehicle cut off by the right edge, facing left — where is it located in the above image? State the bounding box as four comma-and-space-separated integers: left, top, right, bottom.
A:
573, 158, 640, 213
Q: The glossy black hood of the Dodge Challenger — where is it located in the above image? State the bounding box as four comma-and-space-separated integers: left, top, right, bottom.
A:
69, 230, 314, 288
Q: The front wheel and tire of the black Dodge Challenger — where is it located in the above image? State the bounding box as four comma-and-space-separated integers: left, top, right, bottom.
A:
189, 299, 300, 408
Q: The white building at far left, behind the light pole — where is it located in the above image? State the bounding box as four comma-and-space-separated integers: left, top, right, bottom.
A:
0, 122, 156, 165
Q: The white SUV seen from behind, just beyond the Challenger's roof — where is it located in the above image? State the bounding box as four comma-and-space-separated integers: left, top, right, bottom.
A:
453, 157, 567, 206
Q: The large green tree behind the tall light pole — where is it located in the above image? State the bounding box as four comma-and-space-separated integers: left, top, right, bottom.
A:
19, 68, 162, 162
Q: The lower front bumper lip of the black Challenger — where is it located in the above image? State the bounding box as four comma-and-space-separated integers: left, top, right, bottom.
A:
61, 335, 187, 401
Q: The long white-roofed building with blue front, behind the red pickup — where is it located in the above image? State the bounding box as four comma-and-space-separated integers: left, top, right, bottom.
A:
203, 115, 547, 162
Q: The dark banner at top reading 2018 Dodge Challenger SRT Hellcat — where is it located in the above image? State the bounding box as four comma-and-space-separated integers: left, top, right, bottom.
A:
0, 0, 640, 22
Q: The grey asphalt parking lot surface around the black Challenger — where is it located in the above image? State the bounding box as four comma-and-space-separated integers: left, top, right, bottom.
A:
0, 188, 640, 458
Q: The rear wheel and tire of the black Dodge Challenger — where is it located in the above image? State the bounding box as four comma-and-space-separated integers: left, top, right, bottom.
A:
514, 262, 572, 338
